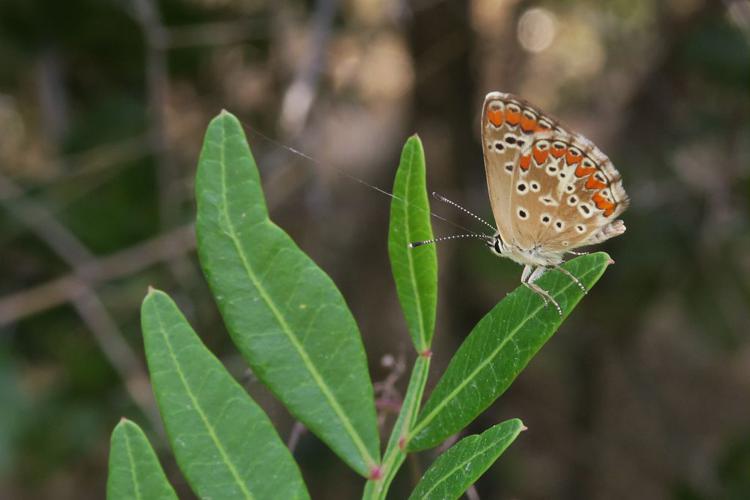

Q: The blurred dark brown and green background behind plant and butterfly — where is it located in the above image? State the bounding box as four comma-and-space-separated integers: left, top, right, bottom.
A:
0, 0, 750, 500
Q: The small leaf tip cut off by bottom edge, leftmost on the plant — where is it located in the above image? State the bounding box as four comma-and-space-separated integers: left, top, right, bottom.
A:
107, 418, 177, 500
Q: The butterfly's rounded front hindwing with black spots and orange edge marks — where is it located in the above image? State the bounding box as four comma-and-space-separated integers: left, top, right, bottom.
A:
511, 130, 629, 254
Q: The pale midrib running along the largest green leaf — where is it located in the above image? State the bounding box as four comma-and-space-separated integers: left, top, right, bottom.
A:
214, 121, 376, 467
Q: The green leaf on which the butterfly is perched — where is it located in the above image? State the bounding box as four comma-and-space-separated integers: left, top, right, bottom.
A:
408, 252, 611, 451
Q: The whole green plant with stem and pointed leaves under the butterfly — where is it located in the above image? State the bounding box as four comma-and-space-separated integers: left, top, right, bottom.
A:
107, 112, 609, 499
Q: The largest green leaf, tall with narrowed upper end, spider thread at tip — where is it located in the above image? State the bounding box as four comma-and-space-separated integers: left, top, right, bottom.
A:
196, 112, 379, 476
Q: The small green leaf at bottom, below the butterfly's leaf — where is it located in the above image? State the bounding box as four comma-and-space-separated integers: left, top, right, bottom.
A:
409, 418, 525, 500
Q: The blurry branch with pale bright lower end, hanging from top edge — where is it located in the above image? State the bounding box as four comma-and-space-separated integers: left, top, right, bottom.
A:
279, 0, 338, 136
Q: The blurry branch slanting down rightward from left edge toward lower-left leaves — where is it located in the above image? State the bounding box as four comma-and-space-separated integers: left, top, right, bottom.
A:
0, 175, 161, 429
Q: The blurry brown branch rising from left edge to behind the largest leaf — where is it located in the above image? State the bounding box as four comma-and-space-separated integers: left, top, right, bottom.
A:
0, 224, 195, 326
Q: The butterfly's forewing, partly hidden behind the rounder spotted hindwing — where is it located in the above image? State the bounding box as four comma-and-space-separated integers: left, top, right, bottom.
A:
482, 92, 557, 246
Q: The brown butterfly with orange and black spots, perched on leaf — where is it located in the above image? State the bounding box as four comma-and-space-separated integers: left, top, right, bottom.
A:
413, 92, 629, 315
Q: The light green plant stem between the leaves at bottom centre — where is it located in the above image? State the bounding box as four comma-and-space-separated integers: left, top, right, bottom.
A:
362, 354, 430, 500
